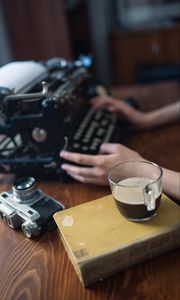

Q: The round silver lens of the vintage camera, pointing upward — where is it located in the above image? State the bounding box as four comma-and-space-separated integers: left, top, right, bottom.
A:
12, 177, 39, 203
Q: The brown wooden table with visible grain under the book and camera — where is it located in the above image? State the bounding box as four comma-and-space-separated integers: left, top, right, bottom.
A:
0, 82, 180, 300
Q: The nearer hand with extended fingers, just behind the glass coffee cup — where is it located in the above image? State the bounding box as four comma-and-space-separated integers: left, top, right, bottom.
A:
60, 143, 142, 185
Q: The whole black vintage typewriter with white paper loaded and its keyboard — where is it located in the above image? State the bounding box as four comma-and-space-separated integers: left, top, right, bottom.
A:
0, 57, 138, 180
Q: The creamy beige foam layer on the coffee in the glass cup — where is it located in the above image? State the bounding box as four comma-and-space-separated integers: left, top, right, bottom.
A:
113, 177, 161, 205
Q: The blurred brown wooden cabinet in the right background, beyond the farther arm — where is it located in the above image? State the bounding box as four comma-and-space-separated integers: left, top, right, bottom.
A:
110, 26, 180, 84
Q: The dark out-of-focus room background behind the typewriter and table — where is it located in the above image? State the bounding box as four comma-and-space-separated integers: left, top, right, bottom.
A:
0, 0, 180, 85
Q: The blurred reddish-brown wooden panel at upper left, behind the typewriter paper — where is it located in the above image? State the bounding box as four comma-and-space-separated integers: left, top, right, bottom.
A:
3, 0, 72, 60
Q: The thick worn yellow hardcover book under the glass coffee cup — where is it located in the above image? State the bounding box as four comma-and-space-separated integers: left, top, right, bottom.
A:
54, 195, 180, 286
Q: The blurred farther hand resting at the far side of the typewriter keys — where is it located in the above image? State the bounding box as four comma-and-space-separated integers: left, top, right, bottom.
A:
91, 95, 148, 128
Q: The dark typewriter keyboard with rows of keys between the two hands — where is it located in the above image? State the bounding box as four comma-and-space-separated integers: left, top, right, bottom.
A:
71, 109, 117, 154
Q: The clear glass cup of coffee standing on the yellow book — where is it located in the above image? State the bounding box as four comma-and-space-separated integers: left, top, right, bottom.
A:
108, 161, 163, 222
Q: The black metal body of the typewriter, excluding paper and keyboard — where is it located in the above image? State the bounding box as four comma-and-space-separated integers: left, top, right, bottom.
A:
0, 58, 118, 178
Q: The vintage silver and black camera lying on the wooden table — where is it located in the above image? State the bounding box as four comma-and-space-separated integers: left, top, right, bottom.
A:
0, 177, 64, 238
